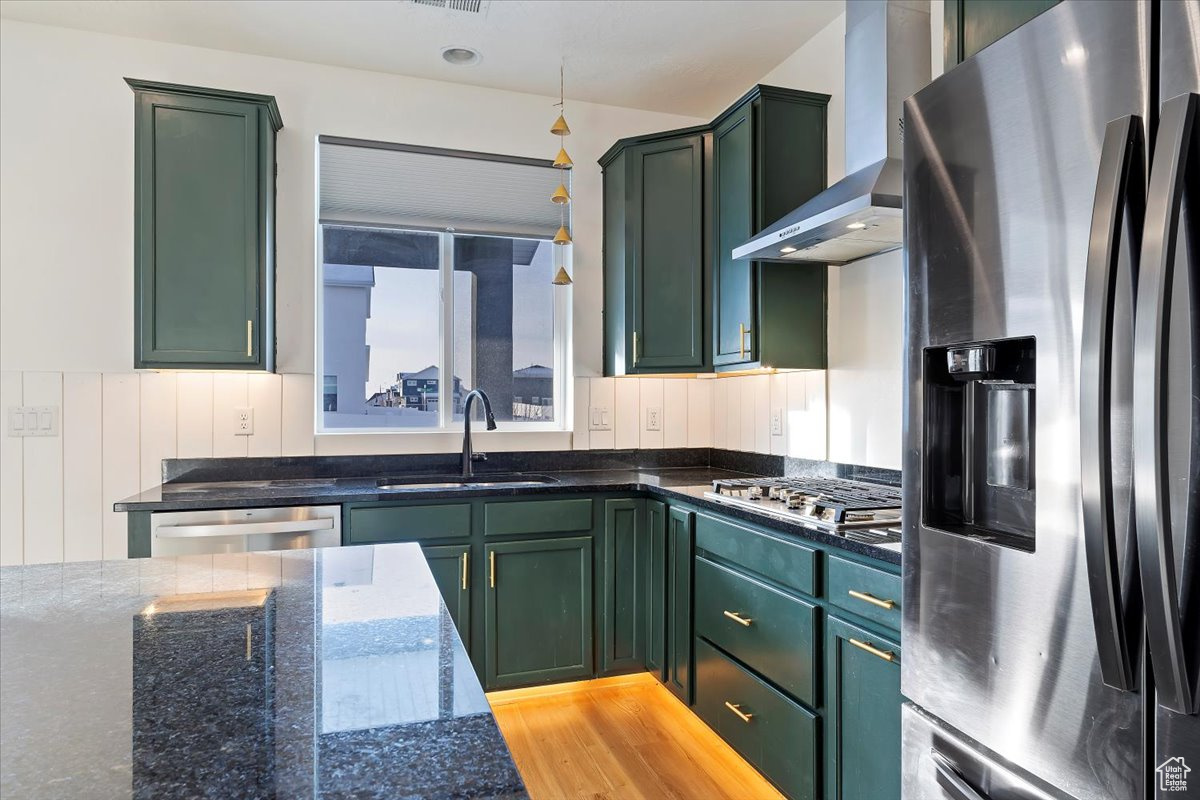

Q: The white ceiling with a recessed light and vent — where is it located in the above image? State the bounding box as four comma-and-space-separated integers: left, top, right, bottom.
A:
0, 0, 845, 116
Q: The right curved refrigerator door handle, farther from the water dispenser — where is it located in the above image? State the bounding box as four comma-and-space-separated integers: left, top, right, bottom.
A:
1133, 94, 1200, 714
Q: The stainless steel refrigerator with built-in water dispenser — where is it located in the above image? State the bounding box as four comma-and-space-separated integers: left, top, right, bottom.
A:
901, 0, 1200, 800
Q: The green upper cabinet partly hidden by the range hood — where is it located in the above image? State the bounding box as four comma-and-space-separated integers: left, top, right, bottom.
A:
713, 86, 829, 371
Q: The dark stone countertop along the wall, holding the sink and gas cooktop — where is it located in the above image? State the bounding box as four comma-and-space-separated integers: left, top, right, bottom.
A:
114, 467, 900, 565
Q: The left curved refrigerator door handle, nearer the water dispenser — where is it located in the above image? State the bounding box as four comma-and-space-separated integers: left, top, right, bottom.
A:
1079, 115, 1146, 691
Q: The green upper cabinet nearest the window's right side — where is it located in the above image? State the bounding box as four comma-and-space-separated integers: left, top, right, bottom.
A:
601, 131, 709, 374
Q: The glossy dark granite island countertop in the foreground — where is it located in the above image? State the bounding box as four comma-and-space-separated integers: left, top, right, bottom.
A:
0, 545, 528, 800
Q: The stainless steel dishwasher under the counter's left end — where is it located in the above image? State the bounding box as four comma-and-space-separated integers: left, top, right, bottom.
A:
150, 505, 342, 555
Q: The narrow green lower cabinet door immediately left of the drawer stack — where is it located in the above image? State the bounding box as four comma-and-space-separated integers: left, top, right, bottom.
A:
666, 509, 696, 705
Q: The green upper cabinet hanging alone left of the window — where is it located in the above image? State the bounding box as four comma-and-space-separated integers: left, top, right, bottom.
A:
126, 78, 283, 371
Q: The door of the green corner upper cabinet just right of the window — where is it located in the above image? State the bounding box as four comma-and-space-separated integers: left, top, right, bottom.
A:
625, 133, 708, 372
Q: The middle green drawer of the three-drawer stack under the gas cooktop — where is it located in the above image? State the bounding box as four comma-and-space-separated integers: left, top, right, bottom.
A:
695, 558, 817, 705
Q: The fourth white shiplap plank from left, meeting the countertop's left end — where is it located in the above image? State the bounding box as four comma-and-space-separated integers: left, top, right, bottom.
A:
101, 373, 139, 559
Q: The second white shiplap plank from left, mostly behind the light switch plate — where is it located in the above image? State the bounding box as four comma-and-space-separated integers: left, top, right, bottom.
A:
22, 372, 62, 564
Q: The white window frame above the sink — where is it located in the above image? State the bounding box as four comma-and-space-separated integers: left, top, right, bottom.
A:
313, 220, 574, 435
